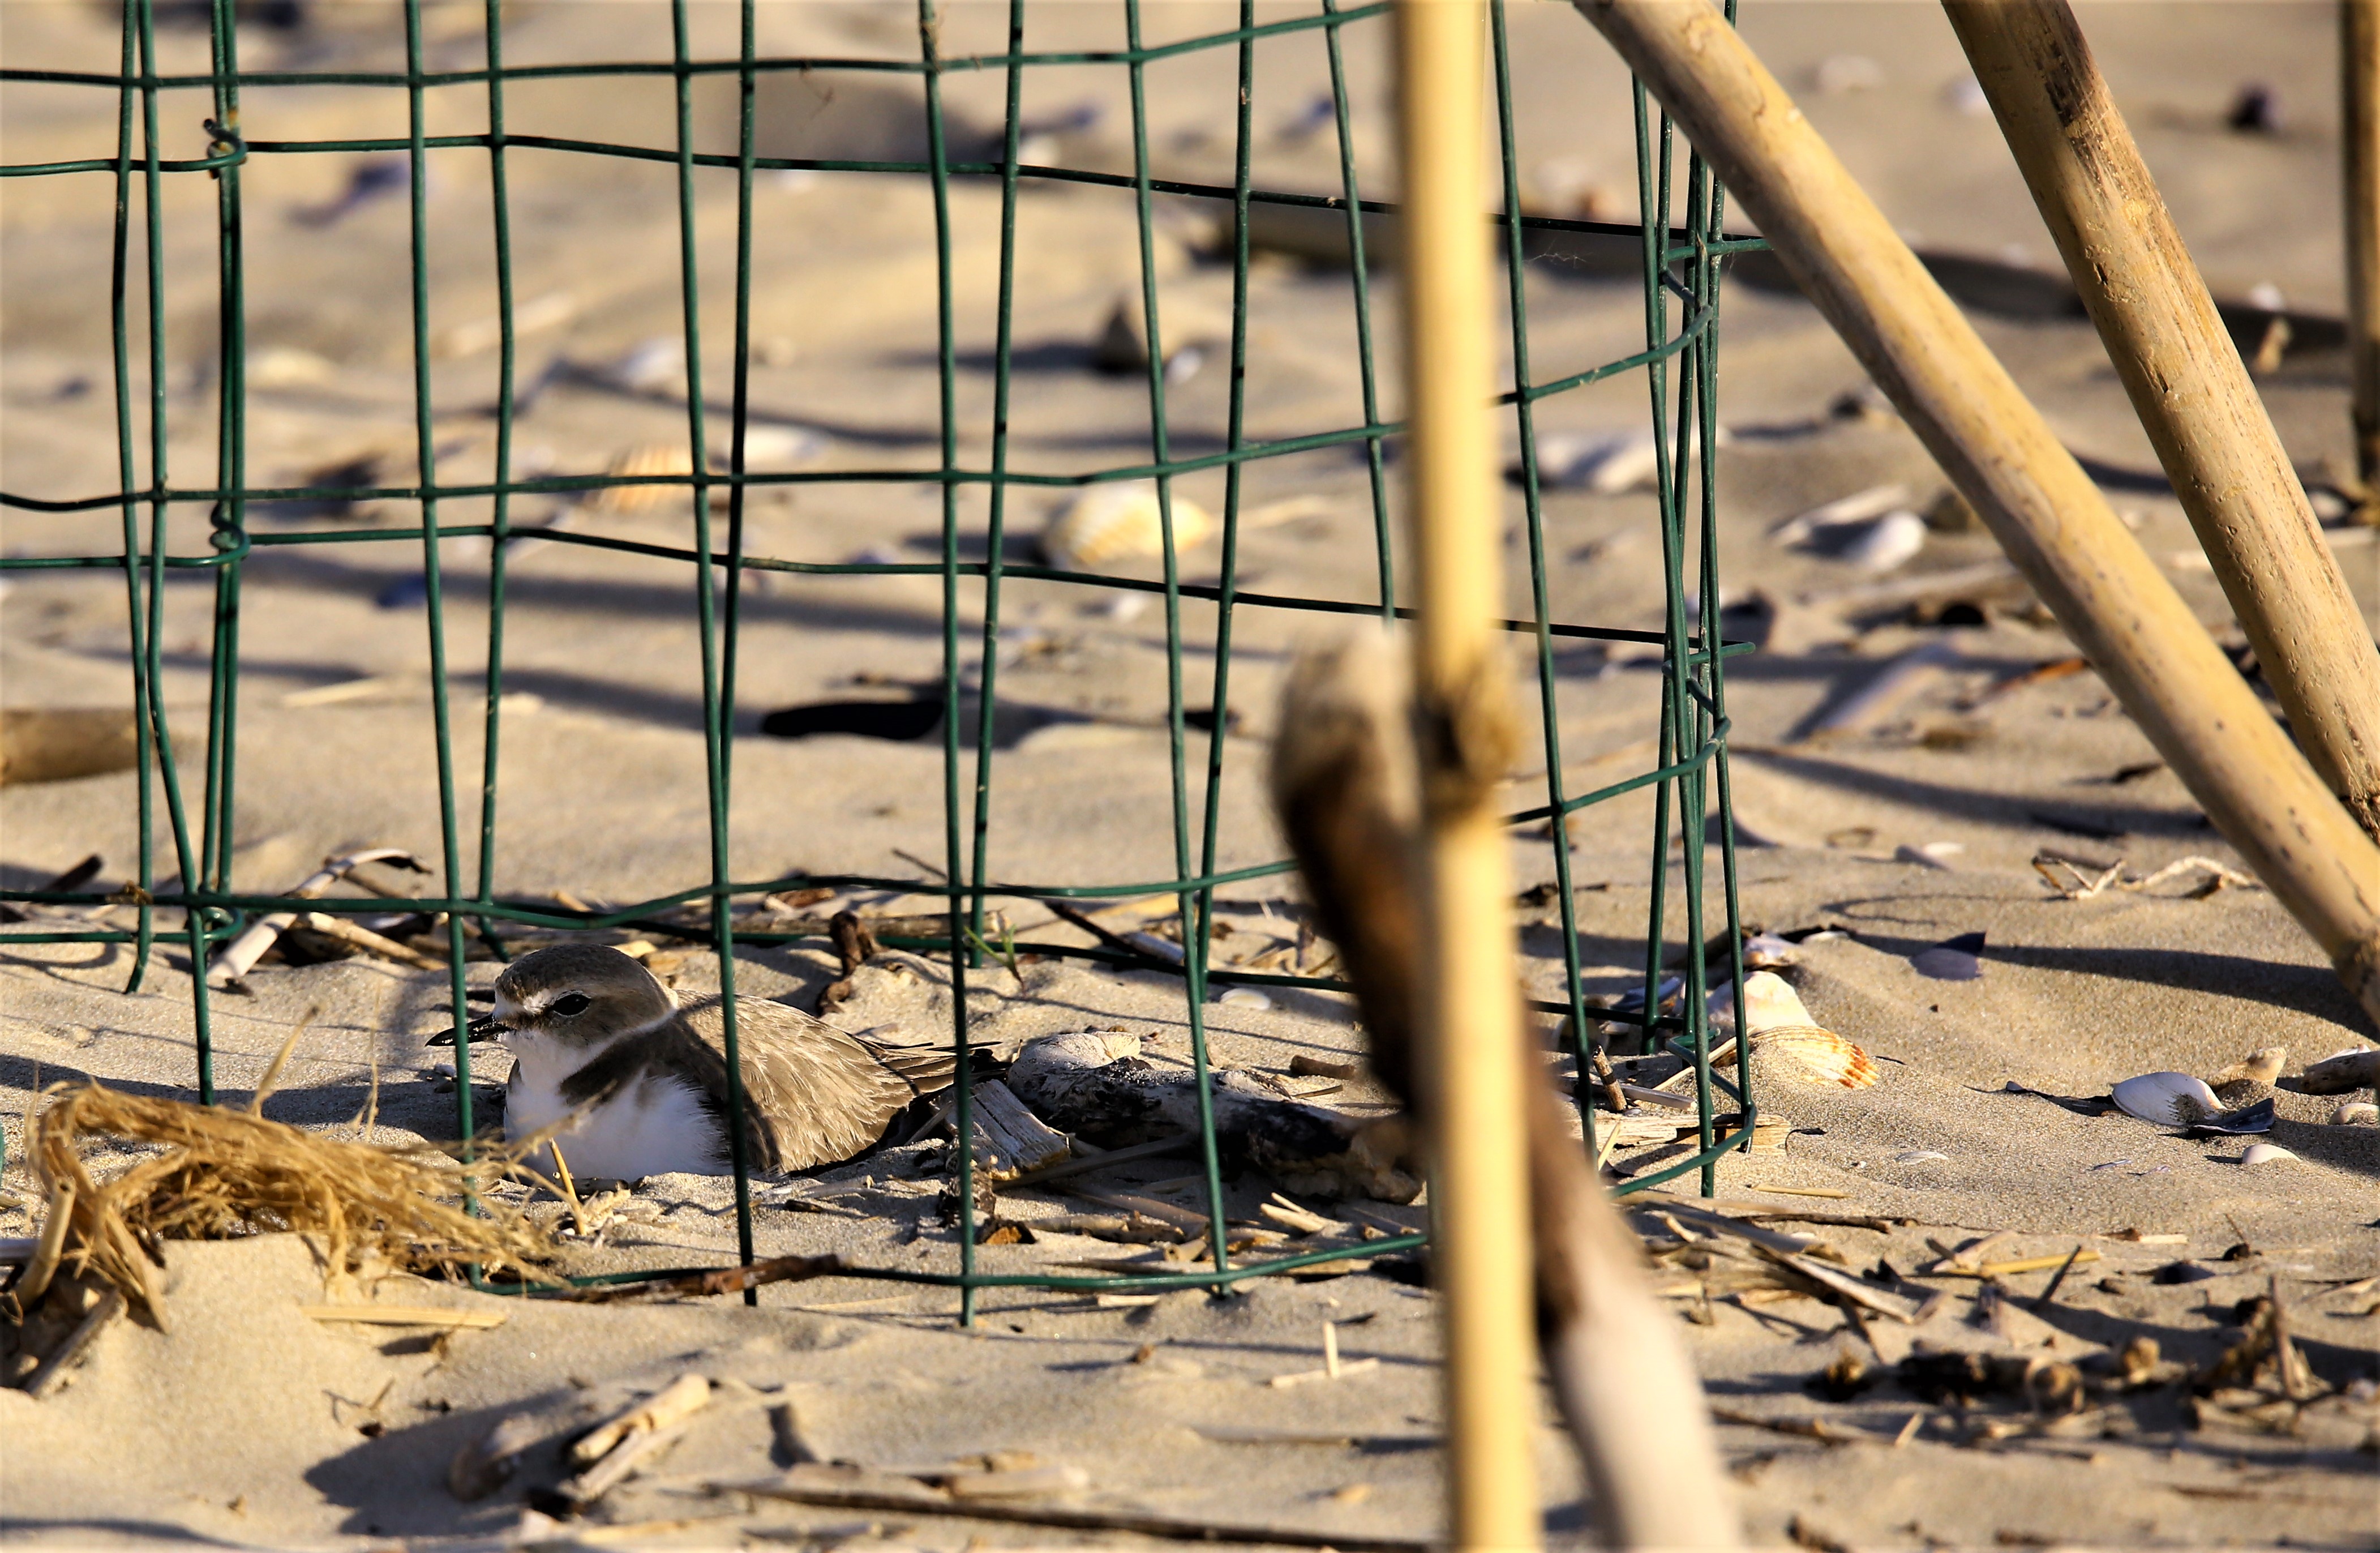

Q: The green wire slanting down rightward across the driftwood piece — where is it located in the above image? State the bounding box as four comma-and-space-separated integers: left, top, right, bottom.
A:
1123, 0, 1230, 1272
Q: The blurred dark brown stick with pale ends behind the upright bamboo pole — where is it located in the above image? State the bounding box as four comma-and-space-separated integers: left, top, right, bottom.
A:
1271, 636, 1742, 1548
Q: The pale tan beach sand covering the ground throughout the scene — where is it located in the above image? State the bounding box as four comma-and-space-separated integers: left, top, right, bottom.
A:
0, 0, 2380, 1548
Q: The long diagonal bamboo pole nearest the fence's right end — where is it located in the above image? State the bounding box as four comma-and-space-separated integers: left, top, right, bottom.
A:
1576, 0, 2380, 1020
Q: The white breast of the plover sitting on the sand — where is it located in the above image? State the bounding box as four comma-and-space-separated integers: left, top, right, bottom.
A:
504, 1036, 728, 1182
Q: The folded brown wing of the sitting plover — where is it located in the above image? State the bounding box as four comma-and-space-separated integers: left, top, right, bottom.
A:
683, 998, 916, 1170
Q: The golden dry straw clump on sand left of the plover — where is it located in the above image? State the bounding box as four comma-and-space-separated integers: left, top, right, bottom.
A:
31, 1084, 555, 1312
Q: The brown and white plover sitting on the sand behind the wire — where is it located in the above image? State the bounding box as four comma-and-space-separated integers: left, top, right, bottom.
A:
443, 943, 954, 1182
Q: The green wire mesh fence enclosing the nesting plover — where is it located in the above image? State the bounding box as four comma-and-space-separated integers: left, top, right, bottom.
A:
0, 0, 1761, 1320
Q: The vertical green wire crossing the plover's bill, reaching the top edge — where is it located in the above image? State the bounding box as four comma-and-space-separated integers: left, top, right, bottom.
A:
405, 0, 474, 1138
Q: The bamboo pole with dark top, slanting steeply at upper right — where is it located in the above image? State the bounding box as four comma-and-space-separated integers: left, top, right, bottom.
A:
1942, 0, 2380, 836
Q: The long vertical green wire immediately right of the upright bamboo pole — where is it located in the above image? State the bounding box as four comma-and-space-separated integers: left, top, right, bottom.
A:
1487, 0, 1594, 1160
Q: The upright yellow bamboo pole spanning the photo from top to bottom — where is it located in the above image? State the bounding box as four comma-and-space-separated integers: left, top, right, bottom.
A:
1397, 0, 1540, 1548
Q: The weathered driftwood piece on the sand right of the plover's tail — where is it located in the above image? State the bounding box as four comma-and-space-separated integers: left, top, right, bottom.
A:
1007, 1032, 1421, 1203
